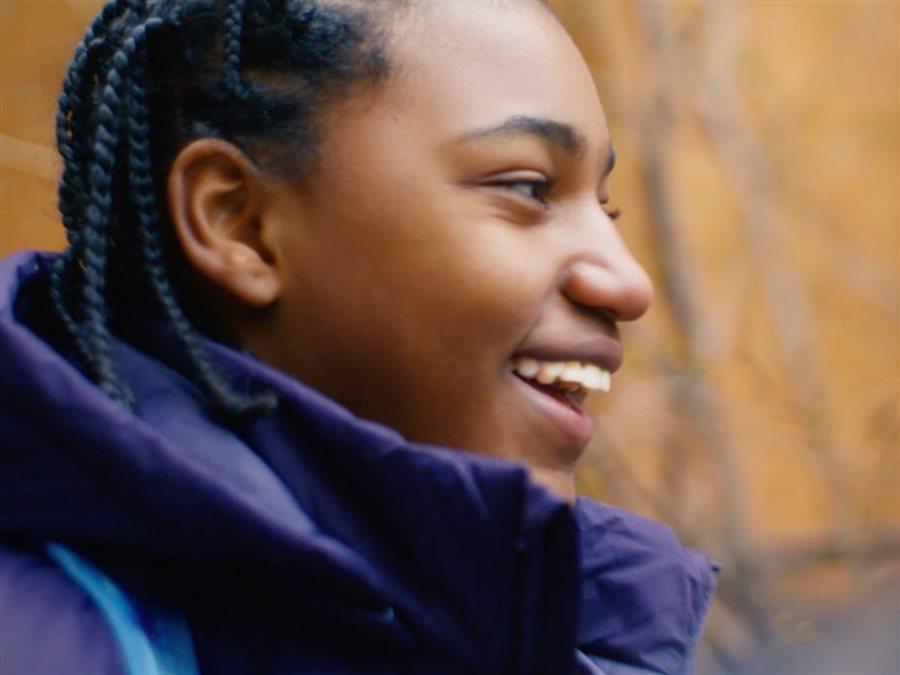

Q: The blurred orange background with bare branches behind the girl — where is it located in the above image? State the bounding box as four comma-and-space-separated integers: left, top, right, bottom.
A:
0, 0, 900, 675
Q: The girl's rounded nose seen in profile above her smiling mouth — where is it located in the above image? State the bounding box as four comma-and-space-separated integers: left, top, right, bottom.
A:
563, 236, 653, 321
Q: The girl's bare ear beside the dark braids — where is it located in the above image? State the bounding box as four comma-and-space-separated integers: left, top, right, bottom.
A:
167, 138, 281, 308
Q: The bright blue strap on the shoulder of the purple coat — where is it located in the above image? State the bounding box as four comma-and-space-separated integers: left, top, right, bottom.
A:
45, 542, 200, 675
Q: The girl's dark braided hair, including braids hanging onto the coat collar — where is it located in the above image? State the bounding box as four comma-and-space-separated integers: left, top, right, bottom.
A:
50, 0, 409, 419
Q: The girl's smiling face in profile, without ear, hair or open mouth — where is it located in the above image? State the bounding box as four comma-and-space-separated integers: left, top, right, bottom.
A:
219, 2, 652, 486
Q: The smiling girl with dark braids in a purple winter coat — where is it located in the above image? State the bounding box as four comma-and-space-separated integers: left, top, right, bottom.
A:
0, 0, 715, 675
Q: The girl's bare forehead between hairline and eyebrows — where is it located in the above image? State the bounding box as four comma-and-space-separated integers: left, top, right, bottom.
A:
381, 0, 609, 152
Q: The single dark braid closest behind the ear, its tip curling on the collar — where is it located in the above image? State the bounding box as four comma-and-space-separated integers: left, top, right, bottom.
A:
128, 19, 275, 417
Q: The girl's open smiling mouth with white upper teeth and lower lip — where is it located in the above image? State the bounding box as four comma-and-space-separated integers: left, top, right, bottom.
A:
509, 356, 610, 446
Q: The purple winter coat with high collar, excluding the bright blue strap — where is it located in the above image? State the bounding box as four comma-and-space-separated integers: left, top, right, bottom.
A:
0, 253, 717, 675
